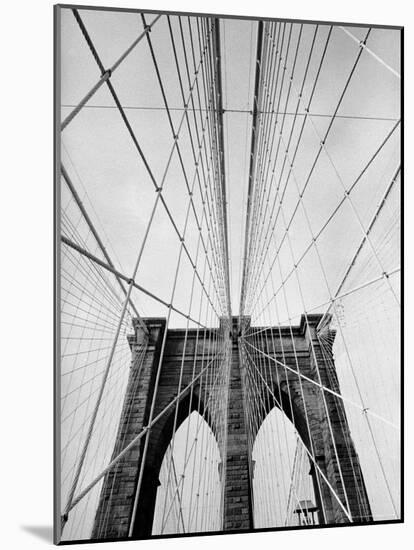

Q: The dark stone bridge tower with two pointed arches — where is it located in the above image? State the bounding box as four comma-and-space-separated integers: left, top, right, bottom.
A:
92, 315, 372, 539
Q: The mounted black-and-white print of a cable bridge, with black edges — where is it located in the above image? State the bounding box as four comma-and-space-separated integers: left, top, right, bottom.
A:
54, 3, 404, 547
